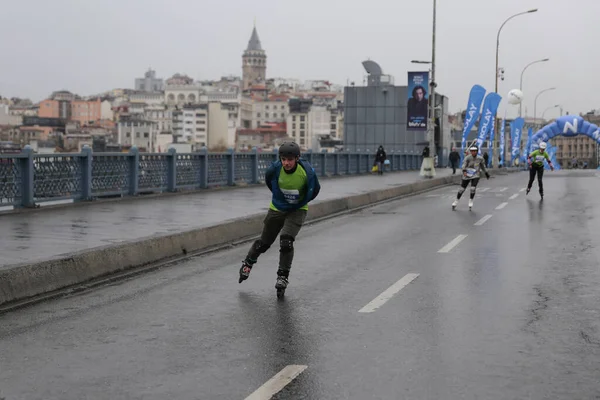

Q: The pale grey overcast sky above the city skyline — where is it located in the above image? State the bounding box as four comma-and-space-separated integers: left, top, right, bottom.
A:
0, 0, 600, 118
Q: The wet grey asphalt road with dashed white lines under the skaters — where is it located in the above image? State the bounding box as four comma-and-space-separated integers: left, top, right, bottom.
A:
0, 171, 600, 400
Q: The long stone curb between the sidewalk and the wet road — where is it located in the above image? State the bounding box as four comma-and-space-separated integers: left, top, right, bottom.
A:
0, 175, 460, 305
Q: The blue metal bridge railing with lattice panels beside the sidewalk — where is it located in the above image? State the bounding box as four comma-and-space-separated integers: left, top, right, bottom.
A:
0, 146, 420, 207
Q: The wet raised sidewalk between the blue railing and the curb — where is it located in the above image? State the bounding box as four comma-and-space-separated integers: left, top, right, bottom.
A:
0, 169, 452, 267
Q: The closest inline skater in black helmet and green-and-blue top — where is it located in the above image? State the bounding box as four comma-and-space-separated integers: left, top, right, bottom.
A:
239, 142, 321, 296
